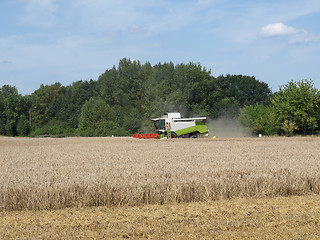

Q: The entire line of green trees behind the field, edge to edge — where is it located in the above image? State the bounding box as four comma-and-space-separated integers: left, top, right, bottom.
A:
0, 58, 320, 136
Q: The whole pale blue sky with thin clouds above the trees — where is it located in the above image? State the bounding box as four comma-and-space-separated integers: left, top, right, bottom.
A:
0, 0, 320, 94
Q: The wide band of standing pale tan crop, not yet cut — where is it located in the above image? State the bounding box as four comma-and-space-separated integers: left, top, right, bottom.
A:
0, 137, 320, 211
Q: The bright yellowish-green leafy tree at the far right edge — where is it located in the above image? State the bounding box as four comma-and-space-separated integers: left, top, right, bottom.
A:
272, 80, 320, 135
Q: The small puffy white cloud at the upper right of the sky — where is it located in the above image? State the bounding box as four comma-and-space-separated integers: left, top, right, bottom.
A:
258, 23, 320, 44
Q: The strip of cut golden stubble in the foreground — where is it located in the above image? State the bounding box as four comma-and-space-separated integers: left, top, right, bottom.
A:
0, 195, 320, 240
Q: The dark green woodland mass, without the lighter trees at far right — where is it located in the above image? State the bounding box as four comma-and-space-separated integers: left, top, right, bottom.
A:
0, 58, 290, 136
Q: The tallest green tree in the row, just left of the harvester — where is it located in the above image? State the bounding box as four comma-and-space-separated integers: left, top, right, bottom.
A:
97, 58, 152, 133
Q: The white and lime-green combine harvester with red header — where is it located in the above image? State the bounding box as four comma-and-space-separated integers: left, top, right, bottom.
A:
133, 113, 208, 139
